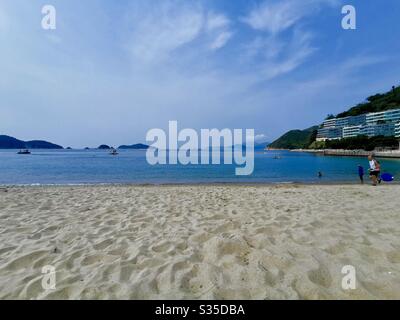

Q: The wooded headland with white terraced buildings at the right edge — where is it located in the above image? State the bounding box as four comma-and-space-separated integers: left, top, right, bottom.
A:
268, 86, 400, 151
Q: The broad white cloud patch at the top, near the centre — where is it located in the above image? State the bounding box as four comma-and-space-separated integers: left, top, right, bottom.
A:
123, 0, 233, 63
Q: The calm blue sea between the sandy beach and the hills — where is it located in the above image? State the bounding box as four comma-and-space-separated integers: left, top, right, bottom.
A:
0, 150, 400, 185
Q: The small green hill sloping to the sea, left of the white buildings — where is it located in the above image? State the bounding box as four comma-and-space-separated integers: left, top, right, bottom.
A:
269, 126, 318, 149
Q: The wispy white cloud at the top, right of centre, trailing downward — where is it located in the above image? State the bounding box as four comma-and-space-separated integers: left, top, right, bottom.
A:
241, 0, 339, 80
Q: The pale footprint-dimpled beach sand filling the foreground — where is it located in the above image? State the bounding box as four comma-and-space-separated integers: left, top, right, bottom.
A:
0, 185, 400, 299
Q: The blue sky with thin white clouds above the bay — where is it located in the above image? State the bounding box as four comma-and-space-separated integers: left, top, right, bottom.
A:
0, 0, 400, 147
